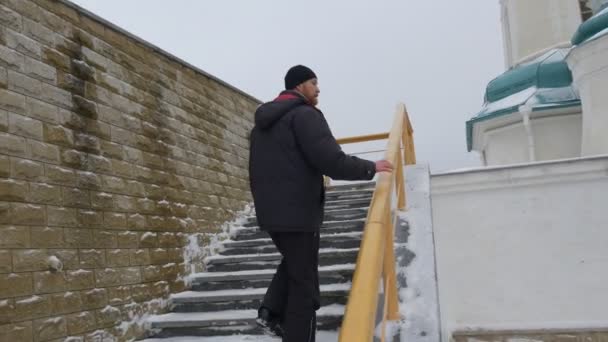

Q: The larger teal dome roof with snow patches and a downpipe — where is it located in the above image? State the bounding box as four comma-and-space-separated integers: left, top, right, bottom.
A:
466, 49, 580, 151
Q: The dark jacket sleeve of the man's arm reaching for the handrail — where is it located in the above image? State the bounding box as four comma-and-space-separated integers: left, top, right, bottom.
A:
292, 107, 376, 180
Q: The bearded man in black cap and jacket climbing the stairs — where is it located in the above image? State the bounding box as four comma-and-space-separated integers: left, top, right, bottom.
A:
249, 65, 392, 342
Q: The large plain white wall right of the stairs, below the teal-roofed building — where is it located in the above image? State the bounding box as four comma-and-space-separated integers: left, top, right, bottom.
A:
431, 156, 608, 341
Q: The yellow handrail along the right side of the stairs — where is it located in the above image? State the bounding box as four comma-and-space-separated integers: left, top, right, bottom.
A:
338, 104, 416, 342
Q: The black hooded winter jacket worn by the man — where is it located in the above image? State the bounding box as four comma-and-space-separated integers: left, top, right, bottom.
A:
249, 91, 376, 232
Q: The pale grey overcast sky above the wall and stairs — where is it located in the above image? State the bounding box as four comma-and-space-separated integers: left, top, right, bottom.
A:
74, 0, 504, 172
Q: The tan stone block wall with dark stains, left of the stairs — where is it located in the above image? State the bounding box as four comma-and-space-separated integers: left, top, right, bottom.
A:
0, 0, 259, 342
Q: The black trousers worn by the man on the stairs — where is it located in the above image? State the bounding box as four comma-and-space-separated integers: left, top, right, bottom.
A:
262, 232, 320, 342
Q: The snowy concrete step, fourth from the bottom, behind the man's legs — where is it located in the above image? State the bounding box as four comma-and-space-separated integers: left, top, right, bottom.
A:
206, 248, 359, 272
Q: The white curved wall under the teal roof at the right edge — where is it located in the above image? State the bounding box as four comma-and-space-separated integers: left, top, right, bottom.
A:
567, 35, 608, 156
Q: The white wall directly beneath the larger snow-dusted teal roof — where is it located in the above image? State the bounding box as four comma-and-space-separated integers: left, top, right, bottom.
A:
475, 108, 582, 166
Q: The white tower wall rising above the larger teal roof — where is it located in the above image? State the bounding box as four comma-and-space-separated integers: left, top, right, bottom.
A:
500, 0, 582, 67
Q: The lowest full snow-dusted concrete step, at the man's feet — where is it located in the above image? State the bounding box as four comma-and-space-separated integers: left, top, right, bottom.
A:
148, 304, 344, 338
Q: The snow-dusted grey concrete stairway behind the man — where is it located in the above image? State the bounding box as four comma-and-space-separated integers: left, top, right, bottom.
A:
149, 182, 375, 338
